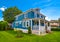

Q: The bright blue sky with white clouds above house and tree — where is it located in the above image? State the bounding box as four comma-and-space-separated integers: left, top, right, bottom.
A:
0, 0, 60, 21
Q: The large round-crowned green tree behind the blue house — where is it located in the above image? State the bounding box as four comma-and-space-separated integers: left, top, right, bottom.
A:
3, 7, 22, 23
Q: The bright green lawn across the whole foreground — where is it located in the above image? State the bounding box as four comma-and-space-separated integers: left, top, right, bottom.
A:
0, 30, 60, 42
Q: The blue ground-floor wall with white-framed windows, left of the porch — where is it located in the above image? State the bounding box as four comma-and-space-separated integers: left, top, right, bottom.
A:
12, 20, 31, 29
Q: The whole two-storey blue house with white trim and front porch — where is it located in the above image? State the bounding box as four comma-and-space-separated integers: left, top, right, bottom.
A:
12, 8, 51, 35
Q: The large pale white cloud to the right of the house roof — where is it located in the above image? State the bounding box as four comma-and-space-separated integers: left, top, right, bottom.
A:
41, 7, 60, 20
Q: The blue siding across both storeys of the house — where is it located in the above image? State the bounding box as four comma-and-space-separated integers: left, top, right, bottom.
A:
12, 11, 44, 29
